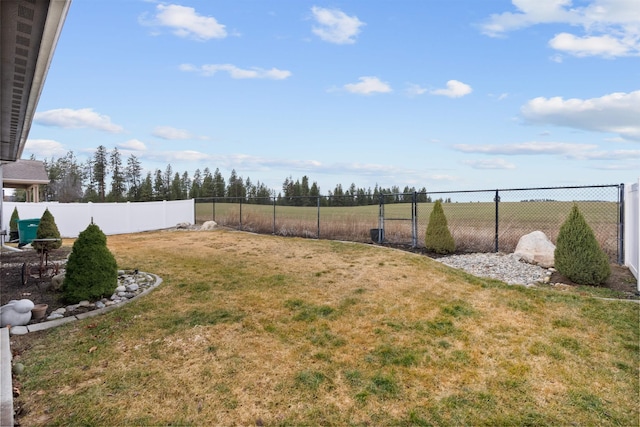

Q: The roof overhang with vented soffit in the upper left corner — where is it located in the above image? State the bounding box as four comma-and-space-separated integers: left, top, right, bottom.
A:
0, 0, 71, 163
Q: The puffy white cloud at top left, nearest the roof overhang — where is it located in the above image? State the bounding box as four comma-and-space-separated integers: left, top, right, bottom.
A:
140, 4, 227, 41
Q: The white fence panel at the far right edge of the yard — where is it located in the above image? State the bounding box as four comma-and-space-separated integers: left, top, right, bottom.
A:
624, 178, 640, 291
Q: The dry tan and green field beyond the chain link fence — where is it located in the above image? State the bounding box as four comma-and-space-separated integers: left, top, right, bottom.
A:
196, 201, 619, 262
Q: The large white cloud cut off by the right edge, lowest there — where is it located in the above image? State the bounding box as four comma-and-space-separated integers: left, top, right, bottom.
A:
520, 90, 640, 141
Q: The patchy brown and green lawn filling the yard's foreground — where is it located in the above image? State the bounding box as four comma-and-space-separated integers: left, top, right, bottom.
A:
12, 230, 640, 426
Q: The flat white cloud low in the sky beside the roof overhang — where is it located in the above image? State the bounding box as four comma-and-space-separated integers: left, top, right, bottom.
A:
33, 108, 124, 133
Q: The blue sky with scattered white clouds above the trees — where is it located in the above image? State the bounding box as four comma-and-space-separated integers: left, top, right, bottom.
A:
23, 0, 640, 194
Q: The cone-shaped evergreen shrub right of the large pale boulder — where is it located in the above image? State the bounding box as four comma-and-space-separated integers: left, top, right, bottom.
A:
554, 204, 611, 285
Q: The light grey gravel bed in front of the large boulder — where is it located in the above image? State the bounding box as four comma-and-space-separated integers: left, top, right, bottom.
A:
436, 252, 554, 286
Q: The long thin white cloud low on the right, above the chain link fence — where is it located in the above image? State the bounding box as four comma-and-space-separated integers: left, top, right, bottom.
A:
453, 141, 598, 157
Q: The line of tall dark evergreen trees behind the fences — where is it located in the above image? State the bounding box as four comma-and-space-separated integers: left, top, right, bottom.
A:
15, 145, 431, 206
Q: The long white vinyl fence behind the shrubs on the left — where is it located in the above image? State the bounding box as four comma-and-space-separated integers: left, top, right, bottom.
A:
2, 199, 195, 237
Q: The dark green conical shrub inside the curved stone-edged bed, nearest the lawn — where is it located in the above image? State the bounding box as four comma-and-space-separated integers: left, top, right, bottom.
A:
62, 224, 118, 303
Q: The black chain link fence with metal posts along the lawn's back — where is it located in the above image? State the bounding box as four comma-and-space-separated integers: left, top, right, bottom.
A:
196, 184, 624, 263
